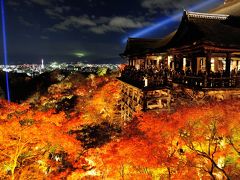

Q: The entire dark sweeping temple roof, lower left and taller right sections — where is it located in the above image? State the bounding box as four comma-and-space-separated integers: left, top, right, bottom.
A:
122, 4, 240, 56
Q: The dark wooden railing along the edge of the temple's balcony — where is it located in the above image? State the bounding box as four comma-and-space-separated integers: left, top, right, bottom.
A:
119, 67, 240, 89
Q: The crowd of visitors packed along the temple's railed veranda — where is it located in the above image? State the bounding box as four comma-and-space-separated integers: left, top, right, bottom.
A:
121, 66, 240, 88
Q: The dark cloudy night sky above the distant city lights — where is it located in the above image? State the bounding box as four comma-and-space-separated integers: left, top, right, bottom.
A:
0, 0, 223, 64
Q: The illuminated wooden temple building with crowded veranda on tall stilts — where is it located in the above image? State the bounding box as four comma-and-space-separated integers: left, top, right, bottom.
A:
119, 1, 240, 119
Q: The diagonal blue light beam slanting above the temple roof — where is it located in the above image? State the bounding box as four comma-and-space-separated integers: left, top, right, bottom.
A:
122, 0, 222, 43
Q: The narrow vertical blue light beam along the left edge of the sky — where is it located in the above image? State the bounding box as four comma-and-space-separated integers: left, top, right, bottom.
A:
1, 0, 11, 102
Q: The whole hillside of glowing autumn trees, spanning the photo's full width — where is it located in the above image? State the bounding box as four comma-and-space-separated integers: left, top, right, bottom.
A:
0, 74, 240, 180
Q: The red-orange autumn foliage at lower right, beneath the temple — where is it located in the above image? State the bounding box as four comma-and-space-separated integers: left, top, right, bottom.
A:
90, 101, 240, 179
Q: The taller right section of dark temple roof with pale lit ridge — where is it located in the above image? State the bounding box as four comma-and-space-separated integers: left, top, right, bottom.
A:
167, 12, 240, 49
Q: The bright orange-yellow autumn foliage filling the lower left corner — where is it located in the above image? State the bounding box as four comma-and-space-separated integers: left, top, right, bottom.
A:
0, 101, 84, 179
